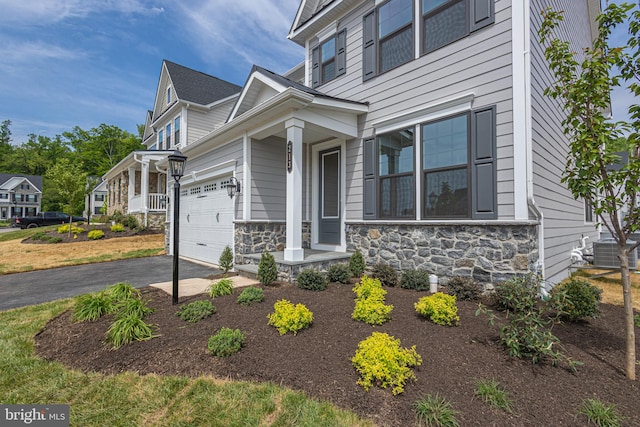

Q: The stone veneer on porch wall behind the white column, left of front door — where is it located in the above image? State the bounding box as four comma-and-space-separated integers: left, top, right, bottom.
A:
235, 221, 311, 261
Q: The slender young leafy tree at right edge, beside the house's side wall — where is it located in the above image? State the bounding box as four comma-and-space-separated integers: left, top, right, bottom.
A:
538, 3, 640, 380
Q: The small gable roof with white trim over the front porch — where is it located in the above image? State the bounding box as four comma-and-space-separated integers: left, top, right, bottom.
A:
227, 65, 368, 122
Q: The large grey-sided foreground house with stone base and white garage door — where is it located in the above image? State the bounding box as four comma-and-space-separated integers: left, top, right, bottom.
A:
104, 0, 600, 283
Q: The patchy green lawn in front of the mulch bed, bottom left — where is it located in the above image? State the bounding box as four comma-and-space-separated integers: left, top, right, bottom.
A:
0, 299, 373, 427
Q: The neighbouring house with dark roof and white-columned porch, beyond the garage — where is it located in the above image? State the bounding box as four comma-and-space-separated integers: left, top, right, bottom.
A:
103, 61, 241, 231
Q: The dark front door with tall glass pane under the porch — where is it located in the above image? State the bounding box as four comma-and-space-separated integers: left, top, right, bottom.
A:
318, 147, 342, 245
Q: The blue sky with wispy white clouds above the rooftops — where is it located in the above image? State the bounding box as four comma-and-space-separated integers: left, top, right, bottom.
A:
0, 0, 633, 144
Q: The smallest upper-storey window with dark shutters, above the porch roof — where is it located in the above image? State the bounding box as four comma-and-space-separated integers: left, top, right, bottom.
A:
311, 30, 347, 87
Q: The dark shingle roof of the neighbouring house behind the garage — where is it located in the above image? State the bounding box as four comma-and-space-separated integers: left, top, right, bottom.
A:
164, 59, 242, 105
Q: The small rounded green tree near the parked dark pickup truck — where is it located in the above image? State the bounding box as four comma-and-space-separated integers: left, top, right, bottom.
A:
45, 158, 87, 237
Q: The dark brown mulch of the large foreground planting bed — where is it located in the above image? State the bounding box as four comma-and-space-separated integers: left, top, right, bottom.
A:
36, 284, 640, 426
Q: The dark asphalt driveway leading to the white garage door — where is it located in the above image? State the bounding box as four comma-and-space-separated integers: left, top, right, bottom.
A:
0, 255, 219, 310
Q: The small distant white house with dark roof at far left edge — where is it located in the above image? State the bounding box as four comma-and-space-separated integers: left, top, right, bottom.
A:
0, 173, 42, 220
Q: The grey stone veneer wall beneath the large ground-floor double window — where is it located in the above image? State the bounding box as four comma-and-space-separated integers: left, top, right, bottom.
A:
346, 223, 538, 284
